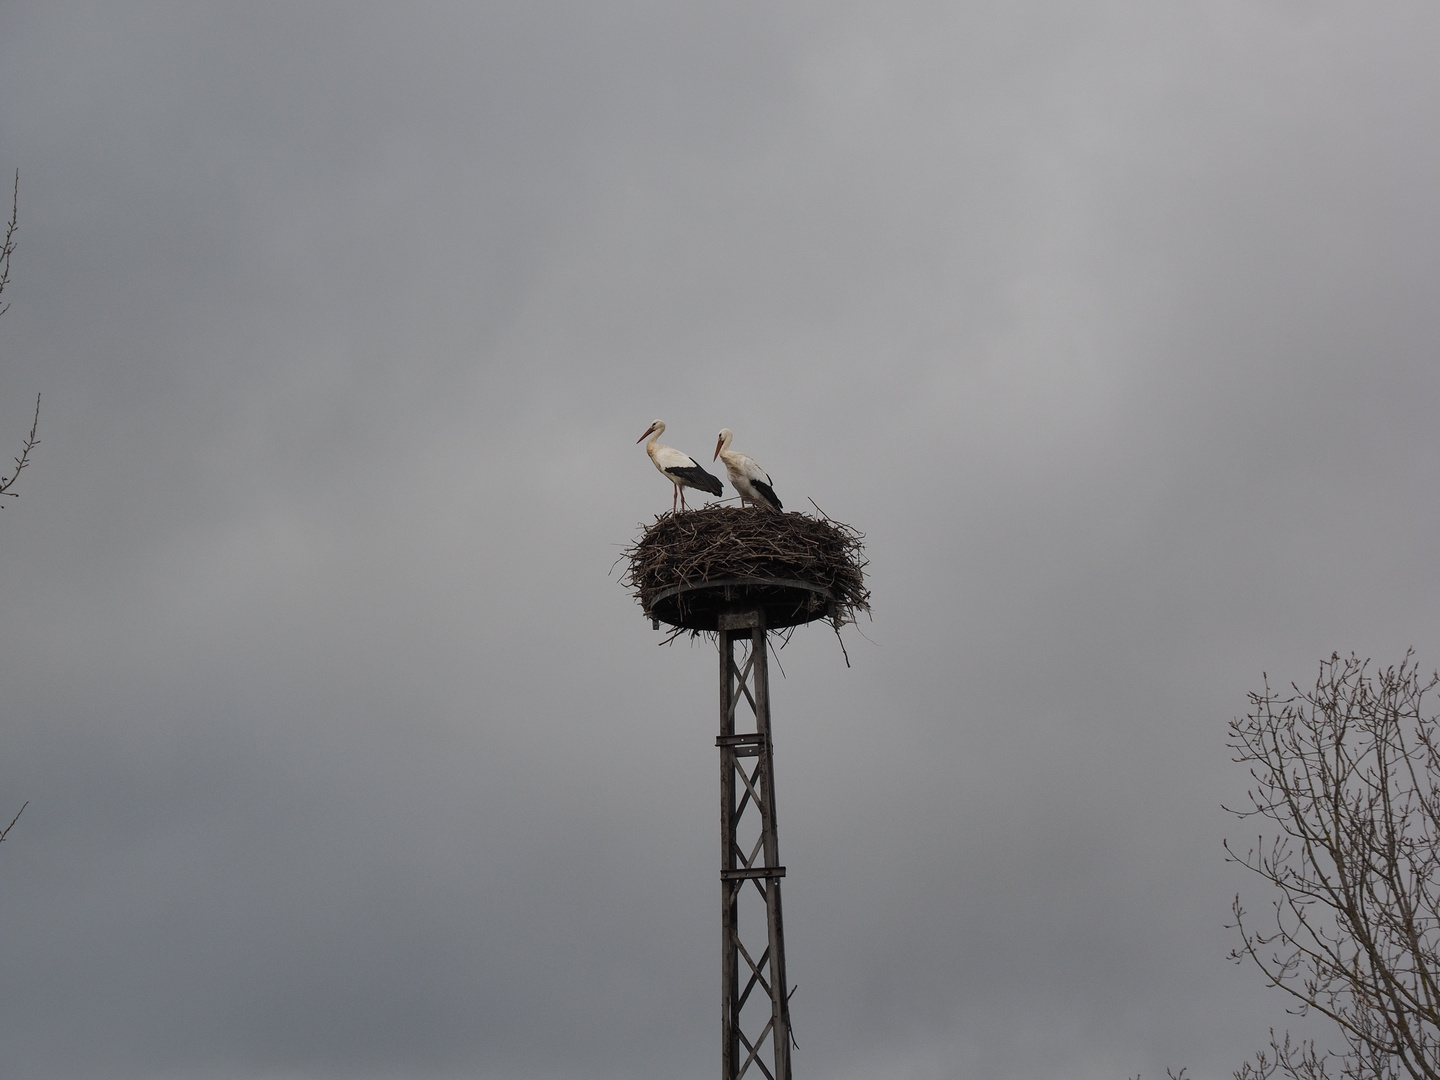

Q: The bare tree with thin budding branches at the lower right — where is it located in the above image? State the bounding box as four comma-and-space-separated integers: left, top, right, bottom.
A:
1225, 652, 1440, 1080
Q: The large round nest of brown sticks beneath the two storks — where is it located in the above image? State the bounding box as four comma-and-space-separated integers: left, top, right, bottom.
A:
621, 505, 870, 631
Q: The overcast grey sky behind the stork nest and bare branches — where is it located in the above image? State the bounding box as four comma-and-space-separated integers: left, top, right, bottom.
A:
0, 0, 1440, 1080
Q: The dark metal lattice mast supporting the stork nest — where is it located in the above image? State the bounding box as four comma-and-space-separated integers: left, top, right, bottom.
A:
716, 611, 791, 1080
